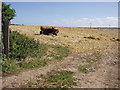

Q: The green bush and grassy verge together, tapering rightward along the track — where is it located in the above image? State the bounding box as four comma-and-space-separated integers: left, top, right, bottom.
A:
2, 31, 69, 73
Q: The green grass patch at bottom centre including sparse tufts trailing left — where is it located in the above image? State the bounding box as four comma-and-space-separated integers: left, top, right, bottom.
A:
23, 71, 76, 88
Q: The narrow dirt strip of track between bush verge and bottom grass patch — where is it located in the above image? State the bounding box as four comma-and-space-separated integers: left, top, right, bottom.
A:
3, 51, 73, 87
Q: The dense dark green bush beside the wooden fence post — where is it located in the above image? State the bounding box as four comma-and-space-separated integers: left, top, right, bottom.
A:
9, 31, 46, 60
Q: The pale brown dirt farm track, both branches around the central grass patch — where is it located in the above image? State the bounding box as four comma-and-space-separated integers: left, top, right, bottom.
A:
3, 53, 118, 88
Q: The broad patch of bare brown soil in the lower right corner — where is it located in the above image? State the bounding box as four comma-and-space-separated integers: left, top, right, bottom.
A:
71, 54, 119, 88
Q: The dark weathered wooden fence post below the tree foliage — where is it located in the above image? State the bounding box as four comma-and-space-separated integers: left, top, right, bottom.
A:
2, 21, 9, 56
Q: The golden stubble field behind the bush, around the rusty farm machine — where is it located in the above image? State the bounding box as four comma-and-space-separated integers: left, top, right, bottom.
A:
10, 25, 118, 53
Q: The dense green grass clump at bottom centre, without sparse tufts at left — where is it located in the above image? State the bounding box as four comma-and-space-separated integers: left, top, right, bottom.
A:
44, 71, 76, 88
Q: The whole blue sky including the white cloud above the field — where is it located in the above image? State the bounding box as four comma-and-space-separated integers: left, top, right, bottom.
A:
6, 2, 118, 27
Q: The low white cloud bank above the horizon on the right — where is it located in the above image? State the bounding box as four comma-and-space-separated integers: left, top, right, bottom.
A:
51, 17, 118, 27
